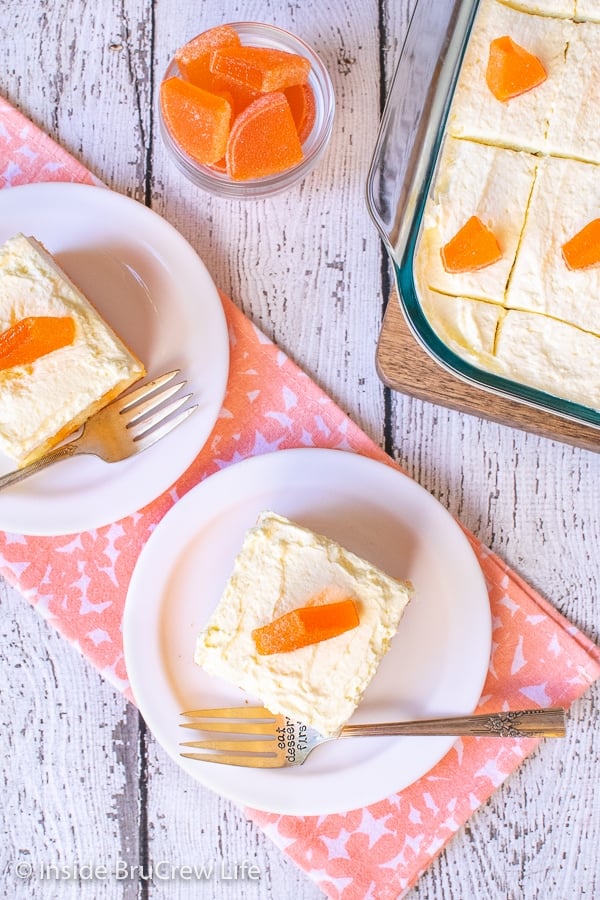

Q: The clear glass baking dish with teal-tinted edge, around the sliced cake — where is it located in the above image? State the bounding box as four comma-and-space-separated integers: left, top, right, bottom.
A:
367, 0, 600, 429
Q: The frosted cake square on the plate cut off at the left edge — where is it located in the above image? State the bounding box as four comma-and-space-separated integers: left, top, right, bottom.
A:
0, 234, 145, 467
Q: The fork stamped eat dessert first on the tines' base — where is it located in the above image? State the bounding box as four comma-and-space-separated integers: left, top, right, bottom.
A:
180, 706, 566, 769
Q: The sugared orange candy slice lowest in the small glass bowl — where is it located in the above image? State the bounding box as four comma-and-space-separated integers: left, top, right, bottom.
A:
225, 91, 304, 181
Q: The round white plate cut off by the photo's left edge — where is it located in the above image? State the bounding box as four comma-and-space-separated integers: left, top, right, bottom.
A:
0, 183, 229, 534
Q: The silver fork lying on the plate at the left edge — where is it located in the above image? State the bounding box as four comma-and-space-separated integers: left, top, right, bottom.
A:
0, 369, 198, 489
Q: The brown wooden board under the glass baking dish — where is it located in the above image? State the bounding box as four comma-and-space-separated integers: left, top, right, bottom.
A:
376, 291, 600, 452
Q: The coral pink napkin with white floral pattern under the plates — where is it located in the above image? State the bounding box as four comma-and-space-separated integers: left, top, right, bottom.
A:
0, 98, 600, 900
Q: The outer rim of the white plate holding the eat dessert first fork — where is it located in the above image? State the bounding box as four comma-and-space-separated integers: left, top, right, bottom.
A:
122, 447, 492, 816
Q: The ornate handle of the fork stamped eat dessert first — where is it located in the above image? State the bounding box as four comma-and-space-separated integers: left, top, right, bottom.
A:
339, 707, 566, 738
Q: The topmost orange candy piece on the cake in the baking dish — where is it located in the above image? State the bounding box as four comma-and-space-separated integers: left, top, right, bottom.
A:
485, 35, 548, 102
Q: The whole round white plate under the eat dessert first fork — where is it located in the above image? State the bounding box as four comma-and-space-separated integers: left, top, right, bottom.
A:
123, 449, 491, 815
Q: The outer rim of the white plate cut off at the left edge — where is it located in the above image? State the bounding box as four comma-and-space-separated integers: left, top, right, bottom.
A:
0, 181, 230, 537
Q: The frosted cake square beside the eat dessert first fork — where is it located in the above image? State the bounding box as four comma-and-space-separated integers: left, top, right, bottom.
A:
195, 512, 412, 736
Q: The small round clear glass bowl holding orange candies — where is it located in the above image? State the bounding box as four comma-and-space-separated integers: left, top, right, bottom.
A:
158, 22, 335, 199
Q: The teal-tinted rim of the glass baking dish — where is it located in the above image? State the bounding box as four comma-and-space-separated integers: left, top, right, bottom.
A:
367, 0, 600, 429
